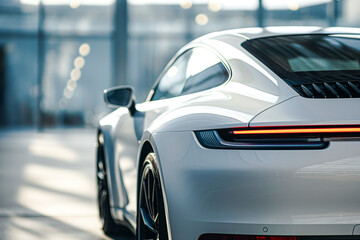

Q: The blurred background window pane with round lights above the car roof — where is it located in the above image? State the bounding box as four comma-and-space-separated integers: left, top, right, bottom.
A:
128, 0, 258, 35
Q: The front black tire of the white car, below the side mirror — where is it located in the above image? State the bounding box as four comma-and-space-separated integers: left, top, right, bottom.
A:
96, 140, 126, 236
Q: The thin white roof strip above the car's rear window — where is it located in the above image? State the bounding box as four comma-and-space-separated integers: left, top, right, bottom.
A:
204, 26, 360, 40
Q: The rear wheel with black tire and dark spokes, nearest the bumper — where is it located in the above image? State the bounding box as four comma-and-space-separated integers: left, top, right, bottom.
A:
136, 153, 169, 240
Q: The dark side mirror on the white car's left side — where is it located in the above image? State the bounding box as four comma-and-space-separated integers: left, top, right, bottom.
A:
104, 86, 136, 115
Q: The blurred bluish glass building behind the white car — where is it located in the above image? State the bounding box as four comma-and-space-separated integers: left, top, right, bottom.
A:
0, 0, 360, 128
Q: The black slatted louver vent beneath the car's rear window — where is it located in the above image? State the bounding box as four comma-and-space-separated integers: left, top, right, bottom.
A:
292, 81, 360, 98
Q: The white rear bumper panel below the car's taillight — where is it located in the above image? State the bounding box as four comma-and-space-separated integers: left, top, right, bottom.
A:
153, 132, 360, 240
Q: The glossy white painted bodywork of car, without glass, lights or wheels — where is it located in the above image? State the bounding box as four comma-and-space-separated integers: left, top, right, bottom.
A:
99, 27, 360, 240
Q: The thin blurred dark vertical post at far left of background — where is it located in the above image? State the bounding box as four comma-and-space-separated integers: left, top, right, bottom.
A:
36, 0, 45, 131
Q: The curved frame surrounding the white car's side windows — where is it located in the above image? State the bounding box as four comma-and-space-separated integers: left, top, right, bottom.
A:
145, 43, 232, 102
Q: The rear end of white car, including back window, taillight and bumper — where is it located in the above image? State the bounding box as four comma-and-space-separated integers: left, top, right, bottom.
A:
154, 31, 360, 240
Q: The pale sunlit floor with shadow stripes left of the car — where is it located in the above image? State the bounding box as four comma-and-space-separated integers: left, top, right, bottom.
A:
0, 129, 133, 240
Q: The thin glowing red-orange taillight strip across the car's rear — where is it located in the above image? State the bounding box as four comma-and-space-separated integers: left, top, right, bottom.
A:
232, 127, 360, 135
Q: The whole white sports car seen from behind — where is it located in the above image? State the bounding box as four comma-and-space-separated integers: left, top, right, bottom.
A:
97, 27, 360, 240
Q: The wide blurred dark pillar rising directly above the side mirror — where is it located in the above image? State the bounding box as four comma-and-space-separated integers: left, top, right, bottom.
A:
112, 0, 129, 85
